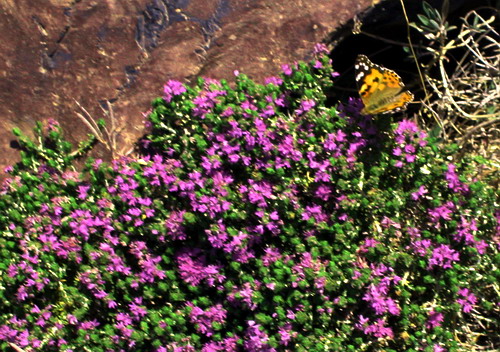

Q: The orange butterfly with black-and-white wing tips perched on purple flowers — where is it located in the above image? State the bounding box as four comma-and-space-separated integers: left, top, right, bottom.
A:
354, 55, 413, 115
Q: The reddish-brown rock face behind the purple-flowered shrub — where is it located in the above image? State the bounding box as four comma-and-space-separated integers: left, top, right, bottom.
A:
0, 0, 372, 170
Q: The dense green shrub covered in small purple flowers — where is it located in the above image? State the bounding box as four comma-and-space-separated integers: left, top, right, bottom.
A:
0, 47, 500, 352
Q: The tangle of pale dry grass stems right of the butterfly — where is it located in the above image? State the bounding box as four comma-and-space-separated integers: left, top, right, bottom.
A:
412, 8, 500, 184
